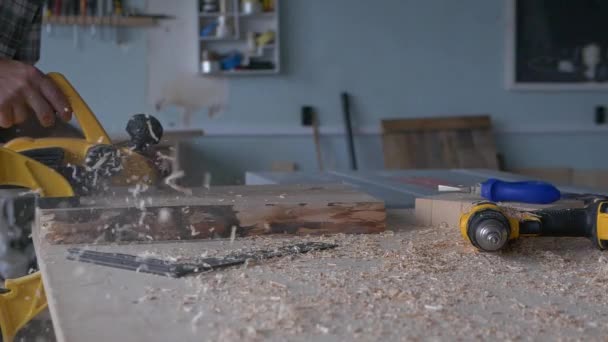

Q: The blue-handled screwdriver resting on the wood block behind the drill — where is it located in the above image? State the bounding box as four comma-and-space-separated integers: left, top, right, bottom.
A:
437, 178, 561, 204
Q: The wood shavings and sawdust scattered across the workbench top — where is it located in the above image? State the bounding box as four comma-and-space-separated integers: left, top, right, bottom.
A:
117, 211, 608, 341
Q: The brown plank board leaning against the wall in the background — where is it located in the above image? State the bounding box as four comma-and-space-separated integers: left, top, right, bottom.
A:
382, 116, 498, 170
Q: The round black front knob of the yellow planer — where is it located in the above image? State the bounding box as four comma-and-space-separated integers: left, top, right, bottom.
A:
127, 114, 163, 152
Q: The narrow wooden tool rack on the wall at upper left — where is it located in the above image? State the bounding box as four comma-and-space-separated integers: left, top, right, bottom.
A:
43, 16, 160, 27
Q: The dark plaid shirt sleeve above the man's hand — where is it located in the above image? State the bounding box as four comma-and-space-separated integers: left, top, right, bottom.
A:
0, 0, 42, 64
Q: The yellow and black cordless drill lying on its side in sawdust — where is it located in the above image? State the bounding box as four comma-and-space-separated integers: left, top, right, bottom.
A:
460, 197, 608, 252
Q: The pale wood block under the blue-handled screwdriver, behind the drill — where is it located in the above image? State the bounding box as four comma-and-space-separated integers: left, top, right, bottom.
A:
414, 193, 584, 228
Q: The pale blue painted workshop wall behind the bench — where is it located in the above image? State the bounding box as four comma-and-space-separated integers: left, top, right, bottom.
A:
40, 0, 608, 182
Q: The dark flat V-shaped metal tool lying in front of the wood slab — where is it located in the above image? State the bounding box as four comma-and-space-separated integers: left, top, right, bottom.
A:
67, 242, 338, 278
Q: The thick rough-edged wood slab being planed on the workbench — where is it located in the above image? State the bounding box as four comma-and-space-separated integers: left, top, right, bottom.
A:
37, 185, 386, 244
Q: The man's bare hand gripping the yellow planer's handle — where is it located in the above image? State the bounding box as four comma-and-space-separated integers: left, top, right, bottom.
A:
0, 59, 72, 128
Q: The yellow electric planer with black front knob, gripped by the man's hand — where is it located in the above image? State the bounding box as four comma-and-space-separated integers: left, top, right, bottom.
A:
0, 73, 163, 195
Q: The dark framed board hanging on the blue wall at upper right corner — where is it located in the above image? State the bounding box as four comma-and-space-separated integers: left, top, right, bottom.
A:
512, 0, 608, 84
